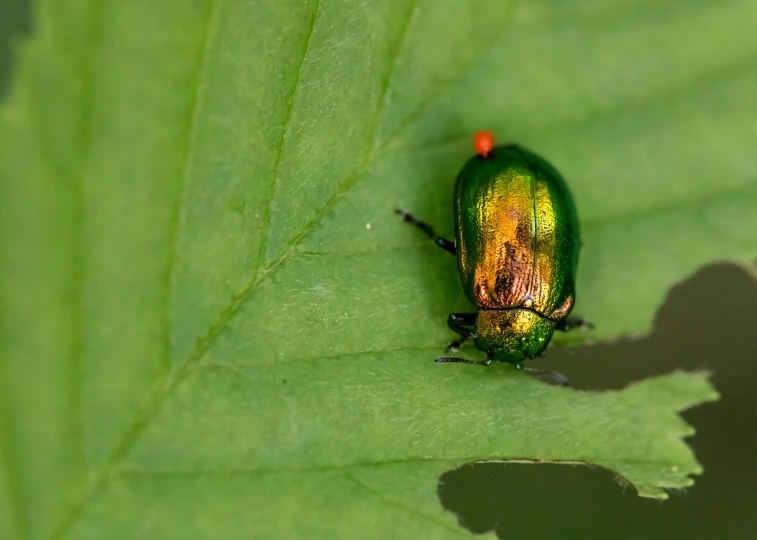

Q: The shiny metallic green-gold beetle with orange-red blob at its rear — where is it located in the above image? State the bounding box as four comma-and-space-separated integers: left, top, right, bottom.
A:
397, 131, 590, 384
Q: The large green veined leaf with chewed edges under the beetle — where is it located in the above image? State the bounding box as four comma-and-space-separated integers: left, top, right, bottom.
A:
0, 0, 757, 539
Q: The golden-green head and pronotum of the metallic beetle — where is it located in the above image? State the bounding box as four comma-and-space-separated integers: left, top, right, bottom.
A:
474, 308, 555, 364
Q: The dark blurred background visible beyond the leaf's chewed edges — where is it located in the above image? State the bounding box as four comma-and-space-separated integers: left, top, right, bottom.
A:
0, 0, 757, 539
